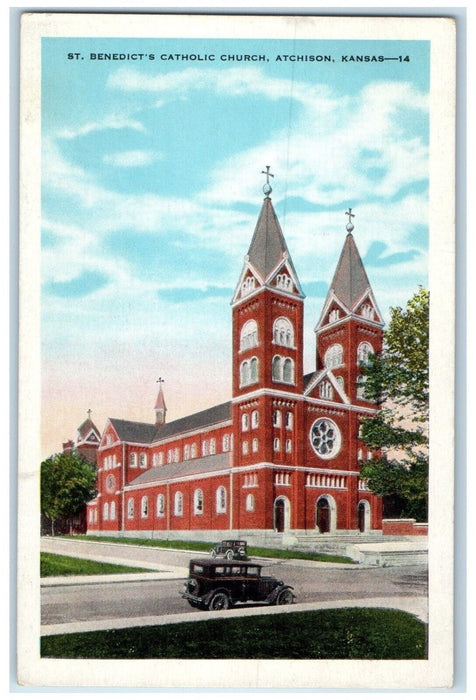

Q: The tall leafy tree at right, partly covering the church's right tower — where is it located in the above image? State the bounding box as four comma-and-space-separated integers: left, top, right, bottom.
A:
361, 287, 429, 520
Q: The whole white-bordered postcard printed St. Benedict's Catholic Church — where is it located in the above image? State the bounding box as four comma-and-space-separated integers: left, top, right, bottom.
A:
18, 12, 456, 691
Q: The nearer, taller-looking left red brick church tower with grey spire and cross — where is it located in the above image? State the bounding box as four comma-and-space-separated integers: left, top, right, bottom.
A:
232, 166, 304, 527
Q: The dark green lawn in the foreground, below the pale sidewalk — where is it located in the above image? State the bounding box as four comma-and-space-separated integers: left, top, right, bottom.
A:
41, 608, 426, 659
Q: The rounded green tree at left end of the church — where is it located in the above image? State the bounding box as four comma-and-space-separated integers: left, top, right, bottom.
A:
40, 453, 96, 534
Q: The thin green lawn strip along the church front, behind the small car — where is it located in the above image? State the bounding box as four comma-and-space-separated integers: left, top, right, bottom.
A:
69, 535, 355, 564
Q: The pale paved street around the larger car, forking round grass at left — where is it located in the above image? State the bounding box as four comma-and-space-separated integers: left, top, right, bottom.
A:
41, 538, 427, 634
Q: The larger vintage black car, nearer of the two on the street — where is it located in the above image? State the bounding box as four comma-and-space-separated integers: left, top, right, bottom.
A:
182, 559, 295, 610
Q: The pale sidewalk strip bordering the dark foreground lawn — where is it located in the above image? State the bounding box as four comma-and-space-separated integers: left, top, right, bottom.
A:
40, 597, 428, 636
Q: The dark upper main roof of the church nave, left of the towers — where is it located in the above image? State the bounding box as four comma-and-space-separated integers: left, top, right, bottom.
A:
110, 401, 231, 445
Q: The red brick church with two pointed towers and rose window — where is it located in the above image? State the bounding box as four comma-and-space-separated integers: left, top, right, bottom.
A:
87, 174, 383, 541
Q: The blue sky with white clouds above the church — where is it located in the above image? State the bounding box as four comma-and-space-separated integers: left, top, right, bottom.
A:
42, 38, 429, 454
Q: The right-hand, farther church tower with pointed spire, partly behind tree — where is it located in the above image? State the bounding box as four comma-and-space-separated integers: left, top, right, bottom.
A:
315, 209, 384, 406
